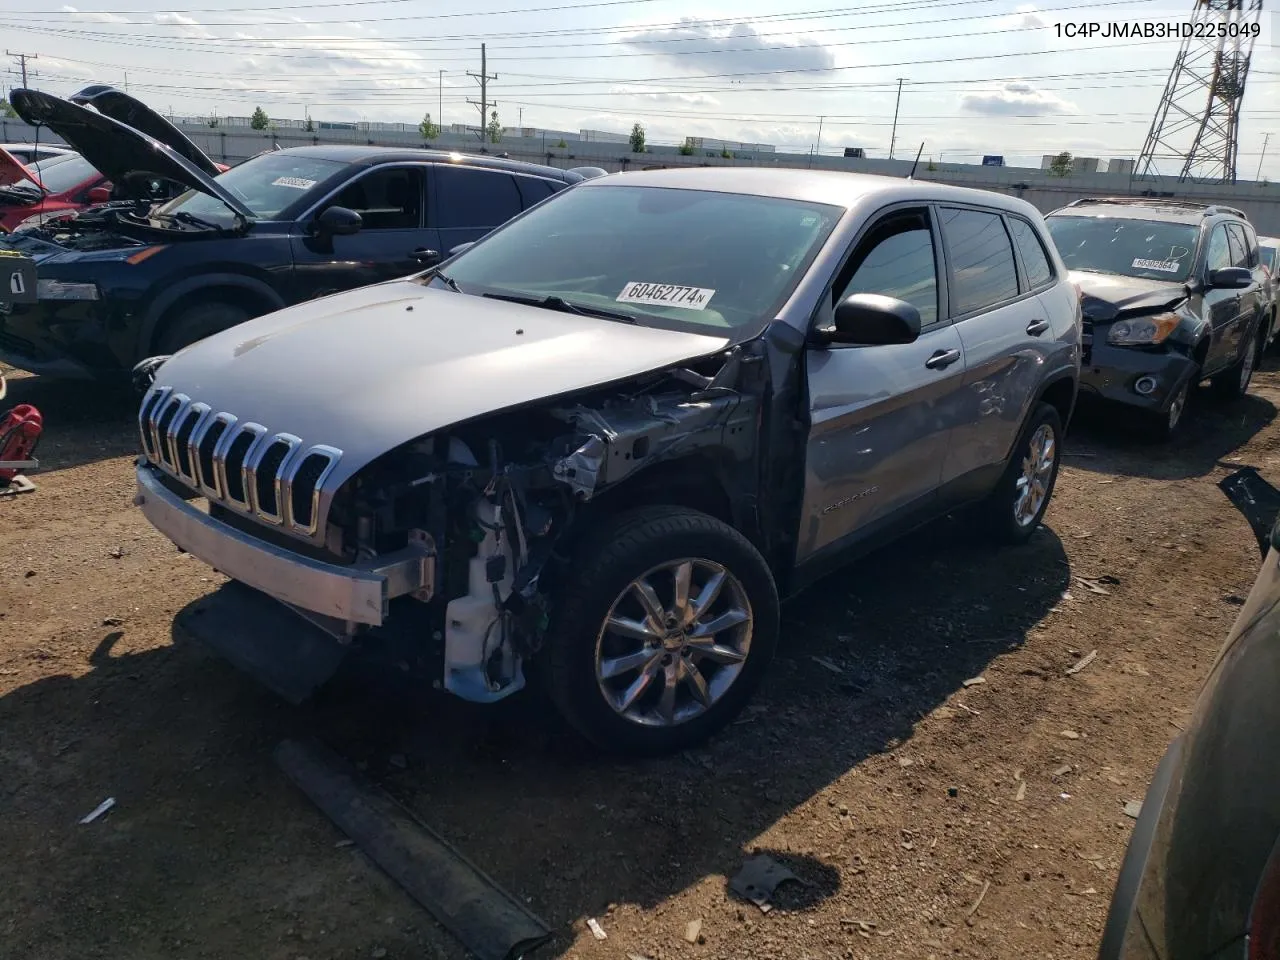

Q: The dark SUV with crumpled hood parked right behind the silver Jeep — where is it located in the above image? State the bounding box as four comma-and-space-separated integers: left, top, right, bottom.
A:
1044, 197, 1271, 436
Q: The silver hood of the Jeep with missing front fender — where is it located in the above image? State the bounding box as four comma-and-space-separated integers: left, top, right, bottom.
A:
155, 280, 730, 490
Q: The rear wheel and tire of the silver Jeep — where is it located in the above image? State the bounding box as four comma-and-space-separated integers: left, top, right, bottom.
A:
983, 403, 1062, 544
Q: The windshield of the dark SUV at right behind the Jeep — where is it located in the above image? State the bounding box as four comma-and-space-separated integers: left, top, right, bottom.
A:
1044, 216, 1199, 282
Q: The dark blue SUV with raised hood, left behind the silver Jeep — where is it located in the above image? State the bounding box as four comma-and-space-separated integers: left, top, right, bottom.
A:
0, 87, 596, 378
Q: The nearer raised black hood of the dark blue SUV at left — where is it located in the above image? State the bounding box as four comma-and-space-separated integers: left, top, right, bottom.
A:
9, 88, 253, 220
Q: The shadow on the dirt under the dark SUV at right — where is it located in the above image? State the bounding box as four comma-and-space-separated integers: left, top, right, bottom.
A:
1065, 378, 1276, 480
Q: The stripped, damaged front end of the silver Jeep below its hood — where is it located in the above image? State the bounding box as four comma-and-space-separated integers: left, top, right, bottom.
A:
136, 344, 767, 703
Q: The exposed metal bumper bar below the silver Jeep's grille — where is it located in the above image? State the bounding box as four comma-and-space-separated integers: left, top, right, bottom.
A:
134, 463, 435, 626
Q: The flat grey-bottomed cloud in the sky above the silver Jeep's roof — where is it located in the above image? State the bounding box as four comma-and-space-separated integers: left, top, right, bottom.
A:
622, 17, 836, 80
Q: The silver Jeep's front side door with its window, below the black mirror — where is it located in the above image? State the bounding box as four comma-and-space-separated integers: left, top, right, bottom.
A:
796, 207, 965, 562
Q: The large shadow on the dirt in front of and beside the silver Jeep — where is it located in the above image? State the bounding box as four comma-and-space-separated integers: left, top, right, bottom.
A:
0, 521, 1070, 957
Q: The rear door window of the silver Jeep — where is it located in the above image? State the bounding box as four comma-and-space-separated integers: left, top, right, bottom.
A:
941, 207, 1018, 315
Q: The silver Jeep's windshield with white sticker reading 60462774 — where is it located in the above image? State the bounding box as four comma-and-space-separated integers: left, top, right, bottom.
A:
428, 186, 845, 330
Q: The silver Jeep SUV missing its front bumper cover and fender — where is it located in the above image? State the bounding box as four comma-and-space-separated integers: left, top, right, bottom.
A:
137, 169, 1080, 753
